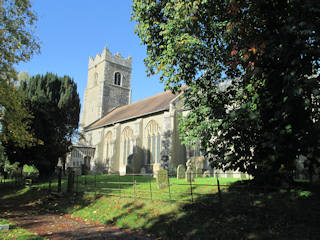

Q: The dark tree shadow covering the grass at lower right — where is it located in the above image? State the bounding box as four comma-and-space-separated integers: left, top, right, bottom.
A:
143, 182, 320, 239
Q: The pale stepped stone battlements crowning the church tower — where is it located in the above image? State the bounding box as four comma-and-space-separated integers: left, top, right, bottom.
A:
88, 47, 132, 69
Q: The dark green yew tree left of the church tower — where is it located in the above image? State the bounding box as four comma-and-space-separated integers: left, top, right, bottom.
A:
6, 73, 80, 178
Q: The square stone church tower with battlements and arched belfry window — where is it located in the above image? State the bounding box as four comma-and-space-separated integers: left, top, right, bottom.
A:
80, 47, 132, 131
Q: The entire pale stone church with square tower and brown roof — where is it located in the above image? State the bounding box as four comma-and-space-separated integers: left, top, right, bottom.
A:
67, 48, 205, 175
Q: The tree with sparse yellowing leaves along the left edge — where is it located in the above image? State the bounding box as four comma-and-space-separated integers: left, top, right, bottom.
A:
0, 0, 39, 147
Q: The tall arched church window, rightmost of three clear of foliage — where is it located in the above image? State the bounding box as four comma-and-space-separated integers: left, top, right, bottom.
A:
146, 120, 161, 164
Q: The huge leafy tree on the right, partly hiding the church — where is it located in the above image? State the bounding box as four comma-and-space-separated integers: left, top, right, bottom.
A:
133, 0, 320, 182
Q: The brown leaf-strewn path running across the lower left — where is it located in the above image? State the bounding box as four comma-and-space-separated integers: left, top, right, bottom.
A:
0, 190, 150, 240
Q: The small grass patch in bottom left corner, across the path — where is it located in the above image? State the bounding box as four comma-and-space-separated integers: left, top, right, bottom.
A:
0, 218, 46, 240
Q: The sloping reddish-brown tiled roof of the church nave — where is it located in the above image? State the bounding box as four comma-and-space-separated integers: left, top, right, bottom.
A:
85, 91, 178, 130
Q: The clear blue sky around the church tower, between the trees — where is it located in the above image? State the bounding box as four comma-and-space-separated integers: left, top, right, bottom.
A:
17, 0, 164, 105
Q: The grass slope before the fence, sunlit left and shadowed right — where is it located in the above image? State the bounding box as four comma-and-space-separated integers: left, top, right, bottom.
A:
69, 179, 320, 239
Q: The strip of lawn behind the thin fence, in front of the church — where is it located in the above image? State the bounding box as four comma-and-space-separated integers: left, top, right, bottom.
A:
42, 175, 241, 202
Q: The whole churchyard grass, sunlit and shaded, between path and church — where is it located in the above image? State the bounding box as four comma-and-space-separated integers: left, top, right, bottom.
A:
0, 175, 320, 239
